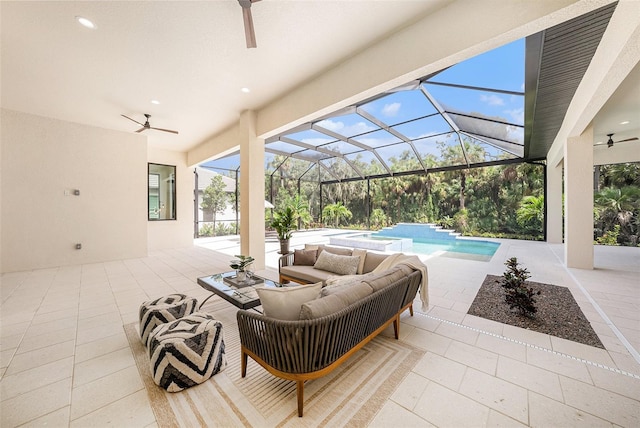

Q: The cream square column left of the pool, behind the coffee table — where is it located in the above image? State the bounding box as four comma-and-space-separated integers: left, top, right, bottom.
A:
239, 111, 265, 270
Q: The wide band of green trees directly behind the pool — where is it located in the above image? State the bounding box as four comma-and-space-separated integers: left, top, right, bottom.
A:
265, 141, 544, 239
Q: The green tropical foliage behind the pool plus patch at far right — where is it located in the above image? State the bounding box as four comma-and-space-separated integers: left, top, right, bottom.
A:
208, 141, 640, 246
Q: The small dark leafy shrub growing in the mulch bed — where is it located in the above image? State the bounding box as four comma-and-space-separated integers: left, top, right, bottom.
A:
500, 257, 540, 318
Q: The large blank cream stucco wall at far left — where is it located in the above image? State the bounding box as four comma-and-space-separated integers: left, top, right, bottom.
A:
0, 109, 147, 272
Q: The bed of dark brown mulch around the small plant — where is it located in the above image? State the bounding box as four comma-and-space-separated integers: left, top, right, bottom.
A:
467, 275, 604, 349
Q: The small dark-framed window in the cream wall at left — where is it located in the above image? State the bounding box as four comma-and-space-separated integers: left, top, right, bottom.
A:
148, 163, 176, 220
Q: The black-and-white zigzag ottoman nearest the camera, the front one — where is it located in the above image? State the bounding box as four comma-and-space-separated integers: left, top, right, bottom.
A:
148, 312, 227, 392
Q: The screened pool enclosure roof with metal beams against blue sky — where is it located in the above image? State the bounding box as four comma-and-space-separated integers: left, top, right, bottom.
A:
203, 39, 525, 181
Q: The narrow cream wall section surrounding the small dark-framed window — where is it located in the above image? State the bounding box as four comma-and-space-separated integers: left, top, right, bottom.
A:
145, 146, 195, 251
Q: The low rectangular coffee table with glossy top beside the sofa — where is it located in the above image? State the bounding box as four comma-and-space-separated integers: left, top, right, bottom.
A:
198, 272, 288, 312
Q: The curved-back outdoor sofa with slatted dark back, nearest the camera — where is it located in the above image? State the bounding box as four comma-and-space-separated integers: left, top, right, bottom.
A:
237, 263, 426, 417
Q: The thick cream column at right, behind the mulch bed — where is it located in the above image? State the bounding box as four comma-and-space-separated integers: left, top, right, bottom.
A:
564, 125, 593, 269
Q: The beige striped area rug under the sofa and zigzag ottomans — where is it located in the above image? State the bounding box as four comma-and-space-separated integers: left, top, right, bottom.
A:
124, 297, 424, 427
